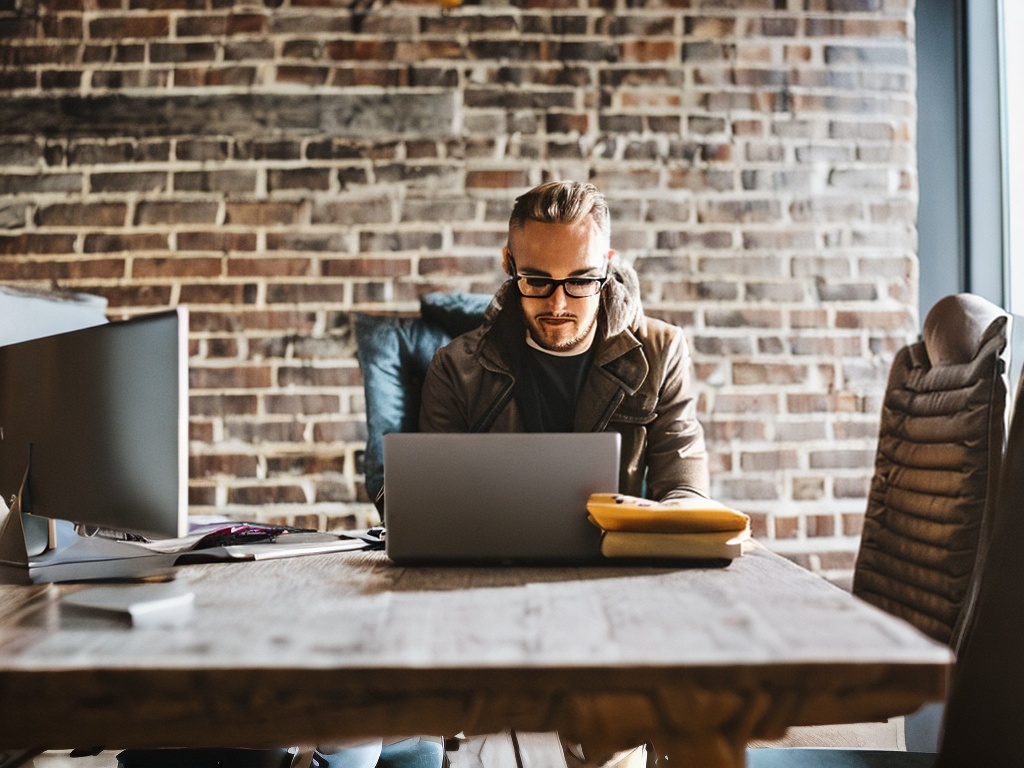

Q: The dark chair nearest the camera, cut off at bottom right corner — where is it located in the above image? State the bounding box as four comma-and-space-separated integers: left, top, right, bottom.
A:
746, 303, 1024, 768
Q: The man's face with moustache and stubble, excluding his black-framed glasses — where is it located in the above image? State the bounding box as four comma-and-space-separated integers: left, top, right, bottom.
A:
505, 221, 612, 352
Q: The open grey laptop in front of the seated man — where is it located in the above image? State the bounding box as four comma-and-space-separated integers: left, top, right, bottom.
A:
384, 432, 621, 564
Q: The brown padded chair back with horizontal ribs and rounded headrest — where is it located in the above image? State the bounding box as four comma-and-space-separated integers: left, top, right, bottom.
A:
853, 294, 1010, 649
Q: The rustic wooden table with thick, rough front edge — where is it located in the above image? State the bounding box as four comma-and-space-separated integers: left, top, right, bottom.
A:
0, 547, 951, 768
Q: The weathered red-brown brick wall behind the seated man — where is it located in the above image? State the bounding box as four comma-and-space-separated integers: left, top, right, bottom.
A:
0, 0, 918, 578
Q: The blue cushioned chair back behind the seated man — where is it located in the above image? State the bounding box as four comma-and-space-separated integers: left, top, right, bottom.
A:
354, 292, 490, 514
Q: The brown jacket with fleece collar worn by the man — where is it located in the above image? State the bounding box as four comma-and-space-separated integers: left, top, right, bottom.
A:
420, 265, 709, 500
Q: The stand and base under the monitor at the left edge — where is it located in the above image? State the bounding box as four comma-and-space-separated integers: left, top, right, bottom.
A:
0, 472, 177, 584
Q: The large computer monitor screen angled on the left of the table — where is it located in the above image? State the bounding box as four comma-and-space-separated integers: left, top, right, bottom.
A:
0, 307, 188, 538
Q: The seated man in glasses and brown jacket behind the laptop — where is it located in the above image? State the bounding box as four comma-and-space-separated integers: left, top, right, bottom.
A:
420, 181, 709, 501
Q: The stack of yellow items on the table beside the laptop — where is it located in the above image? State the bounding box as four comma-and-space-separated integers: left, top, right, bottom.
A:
587, 494, 751, 560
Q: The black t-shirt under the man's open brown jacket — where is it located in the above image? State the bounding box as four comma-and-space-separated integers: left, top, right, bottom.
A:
515, 345, 593, 432
